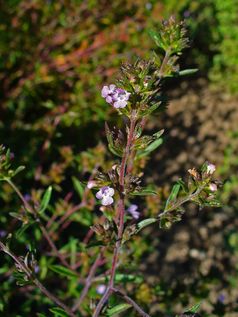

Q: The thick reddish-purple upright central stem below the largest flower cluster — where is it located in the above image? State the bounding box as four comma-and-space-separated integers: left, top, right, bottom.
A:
93, 111, 136, 317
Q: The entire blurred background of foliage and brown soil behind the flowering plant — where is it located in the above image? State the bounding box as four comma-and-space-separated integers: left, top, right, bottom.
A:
0, 0, 238, 317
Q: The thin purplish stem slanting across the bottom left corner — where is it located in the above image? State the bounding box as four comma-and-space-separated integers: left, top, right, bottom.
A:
0, 241, 76, 317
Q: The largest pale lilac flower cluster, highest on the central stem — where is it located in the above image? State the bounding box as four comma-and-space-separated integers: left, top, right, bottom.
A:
102, 85, 130, 108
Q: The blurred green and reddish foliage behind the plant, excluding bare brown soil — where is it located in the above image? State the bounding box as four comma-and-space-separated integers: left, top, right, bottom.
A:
0, 0, 238, 317
